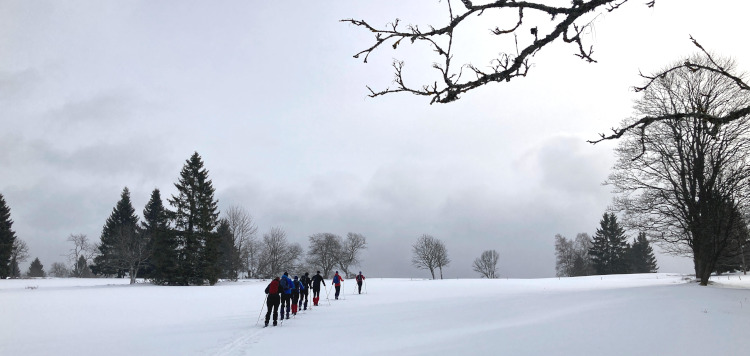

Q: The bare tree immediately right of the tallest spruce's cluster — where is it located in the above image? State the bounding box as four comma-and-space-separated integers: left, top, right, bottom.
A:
225, 205, 259, 278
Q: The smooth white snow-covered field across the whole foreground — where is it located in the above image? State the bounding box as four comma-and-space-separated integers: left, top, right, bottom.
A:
0, 274, 750, 356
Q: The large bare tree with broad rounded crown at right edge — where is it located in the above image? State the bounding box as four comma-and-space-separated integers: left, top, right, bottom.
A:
608, 53, 750, 285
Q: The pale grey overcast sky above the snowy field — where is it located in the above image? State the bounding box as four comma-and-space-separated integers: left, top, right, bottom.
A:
0, 0, 750, 278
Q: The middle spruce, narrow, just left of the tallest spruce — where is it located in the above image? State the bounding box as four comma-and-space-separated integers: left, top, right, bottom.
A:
141, 189, 179, 285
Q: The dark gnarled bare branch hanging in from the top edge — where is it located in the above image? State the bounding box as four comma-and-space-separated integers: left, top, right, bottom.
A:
341, 0, 653, 104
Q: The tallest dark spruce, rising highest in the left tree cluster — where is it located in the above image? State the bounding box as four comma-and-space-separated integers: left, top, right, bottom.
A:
169, 152, 219, 285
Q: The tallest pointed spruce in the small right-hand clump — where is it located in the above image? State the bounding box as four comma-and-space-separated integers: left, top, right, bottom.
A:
589, 213, 630, 274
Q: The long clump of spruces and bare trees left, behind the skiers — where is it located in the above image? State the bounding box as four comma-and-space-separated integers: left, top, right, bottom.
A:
82, 153, 367, 285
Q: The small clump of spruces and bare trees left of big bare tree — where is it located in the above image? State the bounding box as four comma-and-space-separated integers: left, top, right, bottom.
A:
555, 213, 658, 277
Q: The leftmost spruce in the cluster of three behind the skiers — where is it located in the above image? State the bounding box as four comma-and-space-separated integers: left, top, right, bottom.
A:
91, 187, 138, 278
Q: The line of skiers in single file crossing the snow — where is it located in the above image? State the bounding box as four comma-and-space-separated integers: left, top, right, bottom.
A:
265, 271, 365, 326
